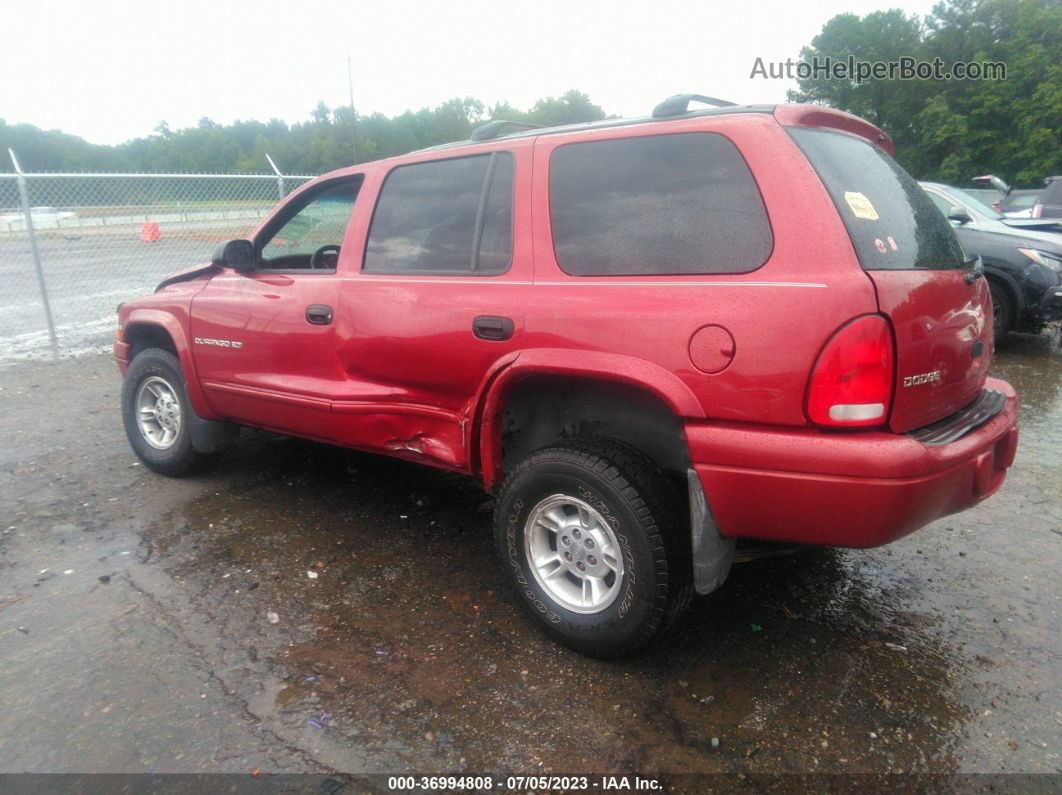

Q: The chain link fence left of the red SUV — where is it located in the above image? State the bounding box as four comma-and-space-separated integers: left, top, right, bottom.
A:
0, 156, 312, 363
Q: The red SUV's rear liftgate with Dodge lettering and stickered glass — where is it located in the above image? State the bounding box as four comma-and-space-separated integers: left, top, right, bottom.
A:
788, 127, 992, 433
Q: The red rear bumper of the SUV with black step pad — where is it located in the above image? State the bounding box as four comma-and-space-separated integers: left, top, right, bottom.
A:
686, 378, 1017, 547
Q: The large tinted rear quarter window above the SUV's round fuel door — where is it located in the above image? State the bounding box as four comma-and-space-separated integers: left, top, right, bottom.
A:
549, 133, 773, 276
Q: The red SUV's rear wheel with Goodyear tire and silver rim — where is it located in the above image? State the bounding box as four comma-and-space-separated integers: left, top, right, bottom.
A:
494, 438, 692, 658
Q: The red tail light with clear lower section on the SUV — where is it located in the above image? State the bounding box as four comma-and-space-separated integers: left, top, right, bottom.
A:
807, 314, 896, 428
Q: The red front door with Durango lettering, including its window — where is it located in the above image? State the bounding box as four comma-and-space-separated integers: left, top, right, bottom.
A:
191, 176, 361, 440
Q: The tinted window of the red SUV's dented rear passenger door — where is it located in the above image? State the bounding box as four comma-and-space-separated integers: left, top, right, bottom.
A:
363, 152, 513, 274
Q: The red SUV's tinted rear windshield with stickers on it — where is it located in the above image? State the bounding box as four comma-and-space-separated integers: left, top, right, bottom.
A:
787, 127, 966, 271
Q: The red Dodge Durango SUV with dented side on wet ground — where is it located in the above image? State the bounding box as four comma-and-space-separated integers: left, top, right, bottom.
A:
115, 94, 1017, 657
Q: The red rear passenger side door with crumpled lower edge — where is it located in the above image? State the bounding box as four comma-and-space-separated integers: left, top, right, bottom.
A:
332, 139, 533, 470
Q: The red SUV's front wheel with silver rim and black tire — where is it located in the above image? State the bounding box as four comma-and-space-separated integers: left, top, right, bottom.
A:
122, 348, 215, 477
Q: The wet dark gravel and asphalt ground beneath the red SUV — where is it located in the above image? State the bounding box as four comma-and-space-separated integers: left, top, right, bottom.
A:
0, 334, 1062, 789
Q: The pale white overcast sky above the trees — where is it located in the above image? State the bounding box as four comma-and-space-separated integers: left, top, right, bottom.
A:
0, 0, 935, 143
